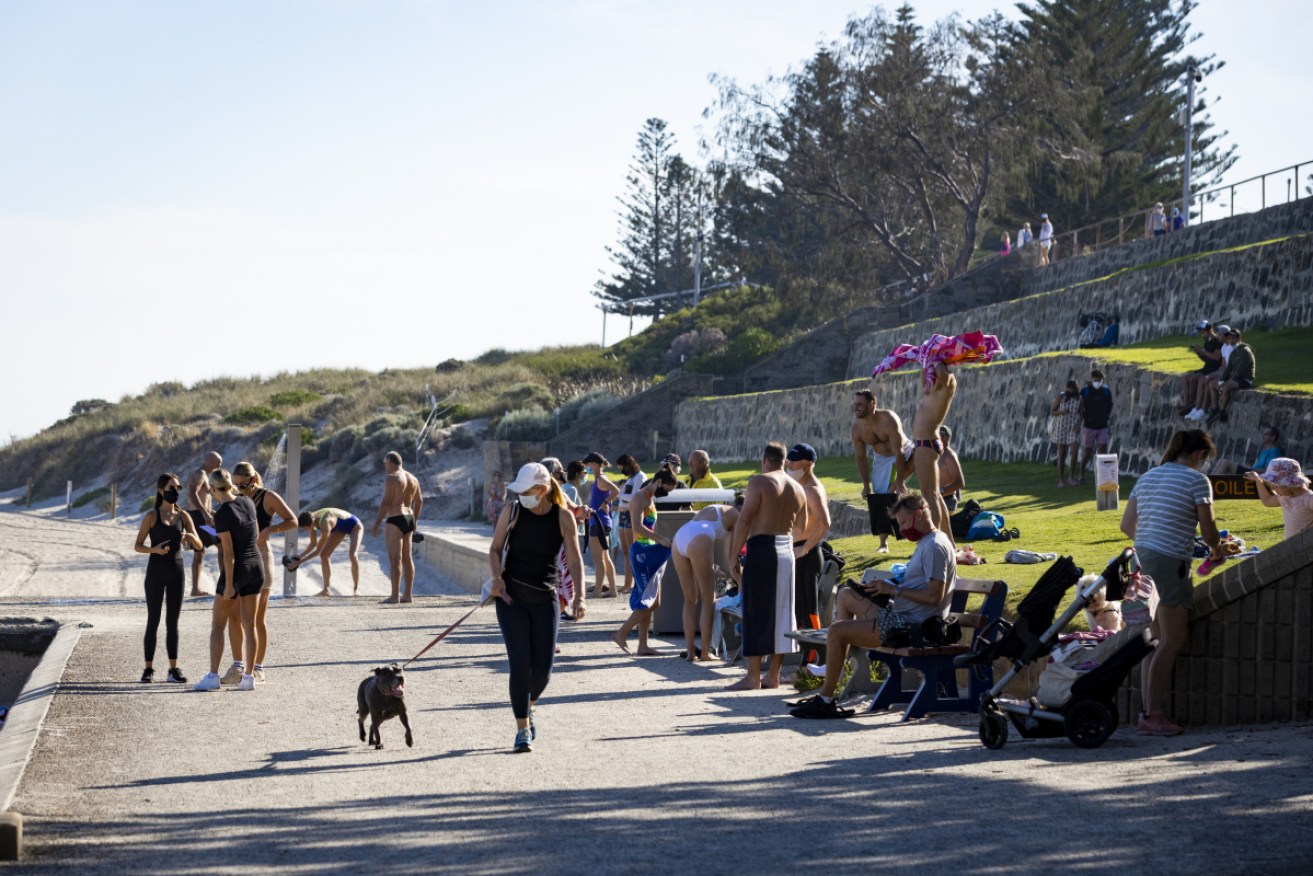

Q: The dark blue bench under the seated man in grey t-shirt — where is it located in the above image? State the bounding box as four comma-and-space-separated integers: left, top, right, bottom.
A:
868, 578, 1007, 721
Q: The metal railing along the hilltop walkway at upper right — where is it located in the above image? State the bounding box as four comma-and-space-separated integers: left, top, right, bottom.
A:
1036, 160, 1313, 263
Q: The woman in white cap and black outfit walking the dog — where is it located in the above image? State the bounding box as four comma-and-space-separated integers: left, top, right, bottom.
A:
488, 462, 584, 751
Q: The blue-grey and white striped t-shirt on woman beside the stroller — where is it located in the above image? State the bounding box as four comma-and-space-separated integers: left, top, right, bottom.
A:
1130, 462, 1213, 559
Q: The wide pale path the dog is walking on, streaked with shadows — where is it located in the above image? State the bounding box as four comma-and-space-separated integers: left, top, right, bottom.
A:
0, 515, 1313, 875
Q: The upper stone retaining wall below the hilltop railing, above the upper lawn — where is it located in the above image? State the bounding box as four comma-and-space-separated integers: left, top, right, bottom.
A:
847, 229, 1313, 378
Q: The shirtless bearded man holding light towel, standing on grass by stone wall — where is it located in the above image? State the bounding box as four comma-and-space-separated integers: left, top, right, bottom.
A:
852, 389, 911, 554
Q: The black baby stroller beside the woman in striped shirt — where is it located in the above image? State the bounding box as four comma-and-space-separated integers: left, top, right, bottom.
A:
955, 548, 1157, 749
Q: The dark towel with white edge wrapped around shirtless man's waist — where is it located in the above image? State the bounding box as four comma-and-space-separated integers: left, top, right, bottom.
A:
739, 535, 798, 657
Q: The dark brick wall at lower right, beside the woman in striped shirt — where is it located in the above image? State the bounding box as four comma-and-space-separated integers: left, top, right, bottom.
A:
1120, 531, 1313, 725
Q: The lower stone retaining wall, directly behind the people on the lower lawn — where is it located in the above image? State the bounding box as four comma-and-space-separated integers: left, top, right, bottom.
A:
675, 355, 1313, 474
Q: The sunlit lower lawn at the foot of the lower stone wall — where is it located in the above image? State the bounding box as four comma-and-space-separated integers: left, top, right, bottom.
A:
716, 457, 1281, 609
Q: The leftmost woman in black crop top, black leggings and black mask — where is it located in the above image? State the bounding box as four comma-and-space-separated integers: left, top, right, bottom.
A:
134, 474, 201, 684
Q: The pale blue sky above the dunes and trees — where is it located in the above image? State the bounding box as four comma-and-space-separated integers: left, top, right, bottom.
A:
0, 0, 1313, 441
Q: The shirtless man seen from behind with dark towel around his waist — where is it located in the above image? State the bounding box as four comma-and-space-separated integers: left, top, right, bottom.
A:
729, 441, 807, 691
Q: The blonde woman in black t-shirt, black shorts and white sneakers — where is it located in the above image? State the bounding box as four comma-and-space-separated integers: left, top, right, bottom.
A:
196, 469, 264, 691
